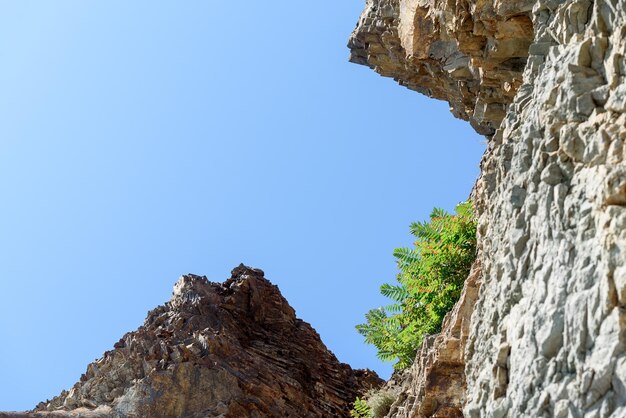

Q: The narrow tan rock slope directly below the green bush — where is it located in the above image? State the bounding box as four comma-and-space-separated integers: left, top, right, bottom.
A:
388, 261, 481, 418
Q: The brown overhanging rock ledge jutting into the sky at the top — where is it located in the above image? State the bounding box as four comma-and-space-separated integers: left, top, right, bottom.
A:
348, 0, 534, 135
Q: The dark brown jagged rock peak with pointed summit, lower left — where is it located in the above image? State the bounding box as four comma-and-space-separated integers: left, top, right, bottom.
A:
6, 265, 381, 418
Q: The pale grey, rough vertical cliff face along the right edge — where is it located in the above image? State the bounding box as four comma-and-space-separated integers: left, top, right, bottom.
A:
465, 0, 626, 417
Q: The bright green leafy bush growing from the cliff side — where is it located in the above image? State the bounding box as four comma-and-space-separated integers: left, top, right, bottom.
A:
356, 202, 476, 369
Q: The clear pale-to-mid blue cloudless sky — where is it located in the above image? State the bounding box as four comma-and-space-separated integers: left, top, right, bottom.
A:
0, 0, 484, 410
